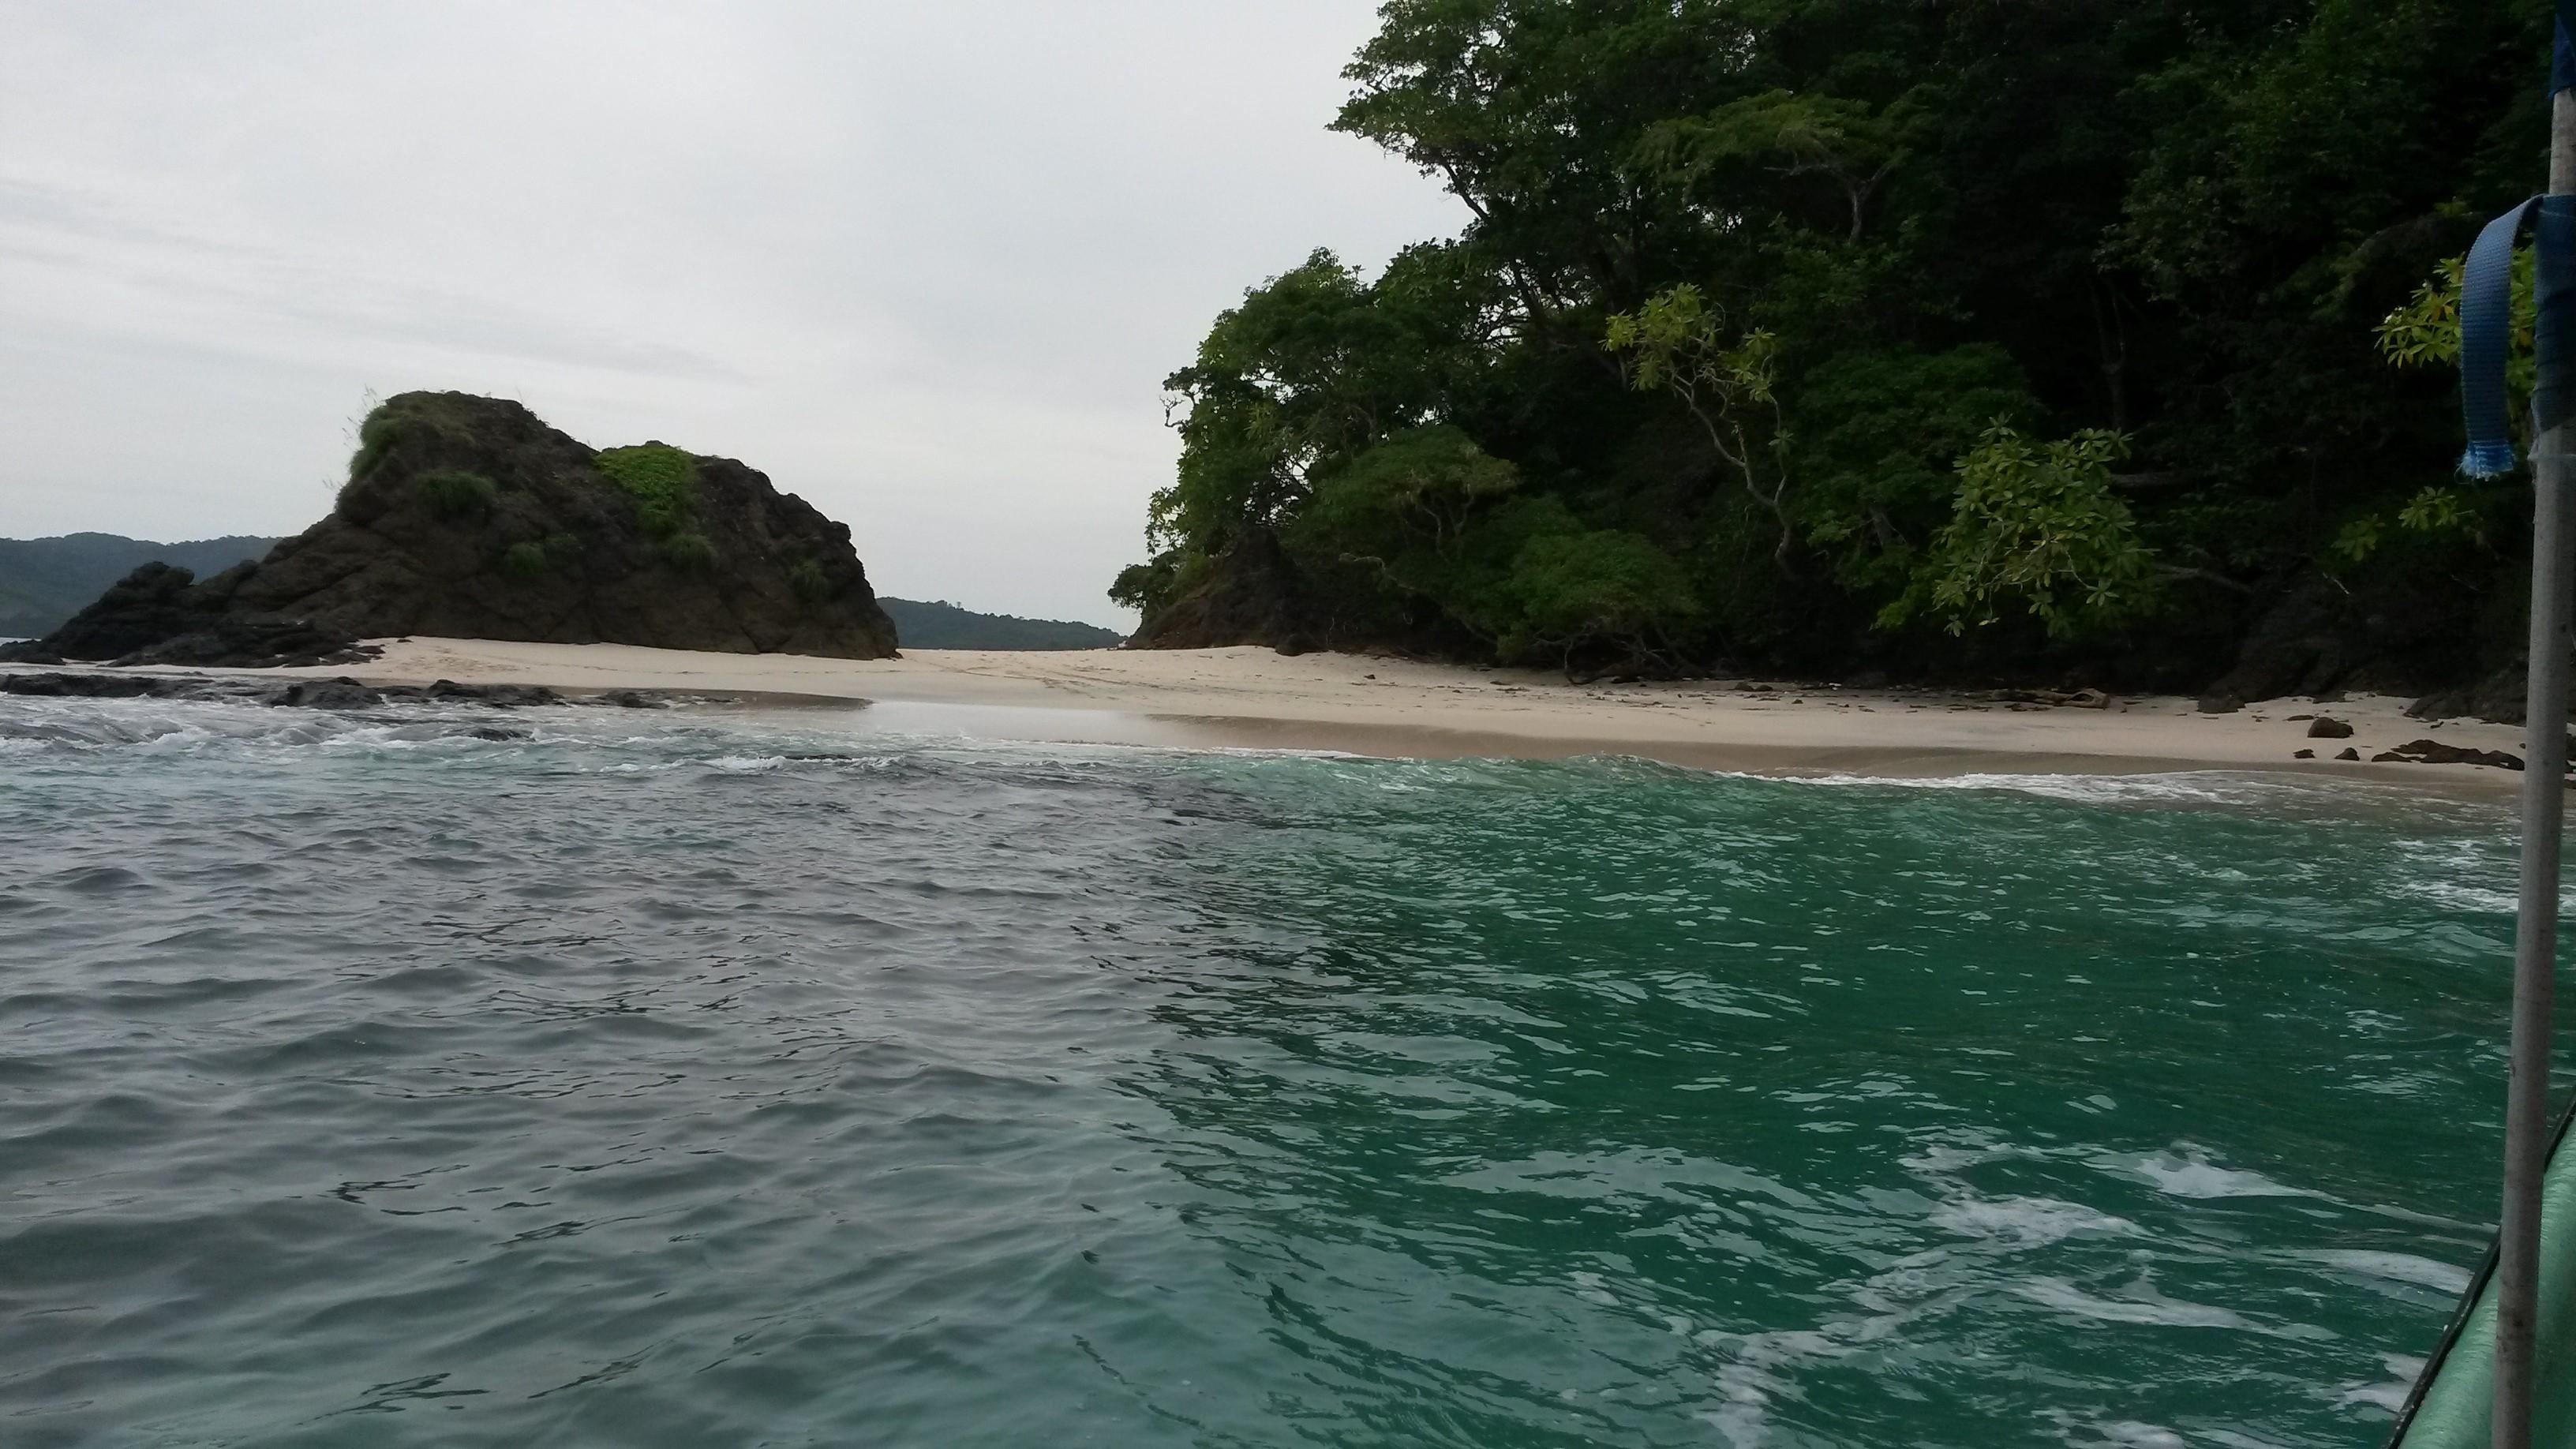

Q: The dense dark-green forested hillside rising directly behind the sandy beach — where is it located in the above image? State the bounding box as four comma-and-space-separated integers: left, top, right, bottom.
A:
1110, 0, 2548, 696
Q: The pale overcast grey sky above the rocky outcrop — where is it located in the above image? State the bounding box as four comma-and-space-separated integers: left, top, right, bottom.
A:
0, 0, 1466, 627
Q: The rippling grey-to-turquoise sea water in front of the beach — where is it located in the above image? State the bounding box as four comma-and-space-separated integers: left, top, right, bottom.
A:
0, 698, 2511, 1449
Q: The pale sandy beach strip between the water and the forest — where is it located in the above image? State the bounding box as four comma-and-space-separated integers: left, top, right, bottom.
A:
20, 637, 2522, 796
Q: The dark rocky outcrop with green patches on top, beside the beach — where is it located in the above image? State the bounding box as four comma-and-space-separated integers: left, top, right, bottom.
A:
2, 392, 894, 663
